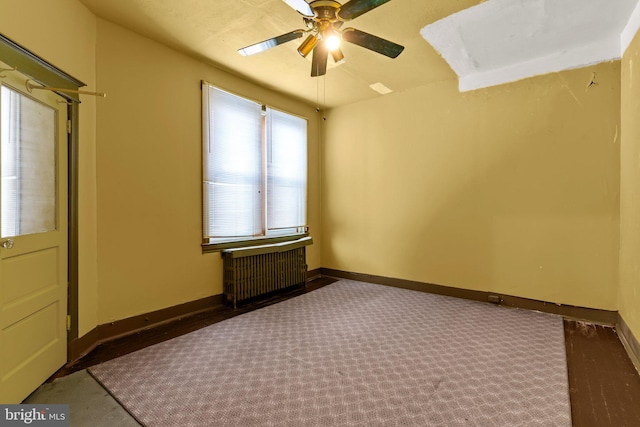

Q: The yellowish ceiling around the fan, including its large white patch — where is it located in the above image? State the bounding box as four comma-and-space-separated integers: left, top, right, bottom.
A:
80, 0, 638, 107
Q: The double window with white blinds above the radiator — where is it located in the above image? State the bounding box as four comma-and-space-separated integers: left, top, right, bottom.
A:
202, 83, 307, 244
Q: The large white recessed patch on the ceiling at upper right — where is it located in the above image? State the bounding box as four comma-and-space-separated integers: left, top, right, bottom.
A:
420, 0, 640, 91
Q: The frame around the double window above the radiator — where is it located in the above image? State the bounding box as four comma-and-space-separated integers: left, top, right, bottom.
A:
202, 81, 309, 251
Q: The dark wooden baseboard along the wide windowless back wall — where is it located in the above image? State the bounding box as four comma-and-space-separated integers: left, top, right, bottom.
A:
320, 268, 618, 326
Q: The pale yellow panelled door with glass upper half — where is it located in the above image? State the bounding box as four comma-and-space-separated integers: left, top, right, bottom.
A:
0, 67, 67, 403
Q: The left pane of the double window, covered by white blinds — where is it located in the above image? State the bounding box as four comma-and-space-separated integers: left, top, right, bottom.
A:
204, 86, 263, 238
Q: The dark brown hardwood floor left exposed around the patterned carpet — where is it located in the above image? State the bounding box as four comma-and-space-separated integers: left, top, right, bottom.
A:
50, 277, 640, 427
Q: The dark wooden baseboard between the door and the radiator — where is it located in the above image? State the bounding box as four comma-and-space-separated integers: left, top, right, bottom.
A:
67, 295, 223, 362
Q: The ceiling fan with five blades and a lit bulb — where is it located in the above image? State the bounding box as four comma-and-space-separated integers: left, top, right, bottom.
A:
238, 0, 404, 77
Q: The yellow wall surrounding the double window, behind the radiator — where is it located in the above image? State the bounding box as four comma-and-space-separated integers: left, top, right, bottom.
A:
97, 19, 320, 323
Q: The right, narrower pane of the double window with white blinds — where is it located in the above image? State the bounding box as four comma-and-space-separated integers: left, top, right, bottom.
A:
267, 109, 307, 230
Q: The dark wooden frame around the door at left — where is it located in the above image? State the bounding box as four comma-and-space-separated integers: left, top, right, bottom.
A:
0, 33, 86, 348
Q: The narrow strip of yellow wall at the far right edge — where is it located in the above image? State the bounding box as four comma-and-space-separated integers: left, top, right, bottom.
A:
618, 30, 640, 339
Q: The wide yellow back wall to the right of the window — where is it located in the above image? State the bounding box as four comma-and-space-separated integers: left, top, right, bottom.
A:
322, 61, 620, 310
